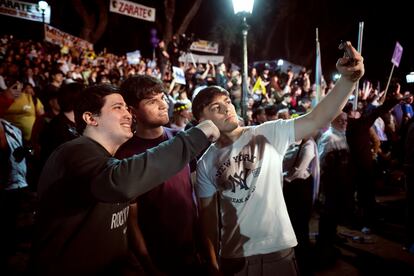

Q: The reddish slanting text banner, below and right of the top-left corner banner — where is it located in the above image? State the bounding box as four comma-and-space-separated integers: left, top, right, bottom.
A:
45, 24, 93, 50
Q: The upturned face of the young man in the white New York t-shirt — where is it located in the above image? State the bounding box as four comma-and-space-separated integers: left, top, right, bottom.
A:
200, 95, 239, 132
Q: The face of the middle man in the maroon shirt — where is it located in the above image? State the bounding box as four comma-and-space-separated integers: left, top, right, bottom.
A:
135, 93, 169, 127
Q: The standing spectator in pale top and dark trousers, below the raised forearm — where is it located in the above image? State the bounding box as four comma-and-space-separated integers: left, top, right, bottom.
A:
316, 111, 354, 266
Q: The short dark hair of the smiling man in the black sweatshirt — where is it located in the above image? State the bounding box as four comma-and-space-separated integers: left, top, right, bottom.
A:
74, 84, 121, 134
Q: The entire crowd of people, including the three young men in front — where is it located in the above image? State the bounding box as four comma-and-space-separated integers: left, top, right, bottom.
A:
0, 36, 414, 275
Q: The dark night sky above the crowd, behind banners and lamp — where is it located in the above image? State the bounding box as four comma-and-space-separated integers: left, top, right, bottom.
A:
0, 0, 414, 87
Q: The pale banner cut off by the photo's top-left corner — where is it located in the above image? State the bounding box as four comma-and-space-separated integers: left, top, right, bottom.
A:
0, 0, 50, 24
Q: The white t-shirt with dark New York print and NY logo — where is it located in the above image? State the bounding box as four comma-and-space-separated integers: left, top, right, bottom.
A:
196, 120, 297, 258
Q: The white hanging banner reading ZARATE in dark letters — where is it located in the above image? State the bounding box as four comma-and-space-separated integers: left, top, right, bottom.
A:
109, 0, 155, 22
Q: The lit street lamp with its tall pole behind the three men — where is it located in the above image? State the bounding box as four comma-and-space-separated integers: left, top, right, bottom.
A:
232, 0, 254, 125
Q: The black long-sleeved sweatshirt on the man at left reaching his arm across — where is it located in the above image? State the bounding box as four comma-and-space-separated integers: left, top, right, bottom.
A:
32, 128, 209, 275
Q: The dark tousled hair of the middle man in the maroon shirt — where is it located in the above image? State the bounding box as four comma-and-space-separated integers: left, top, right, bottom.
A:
121, 75, 166, 107
